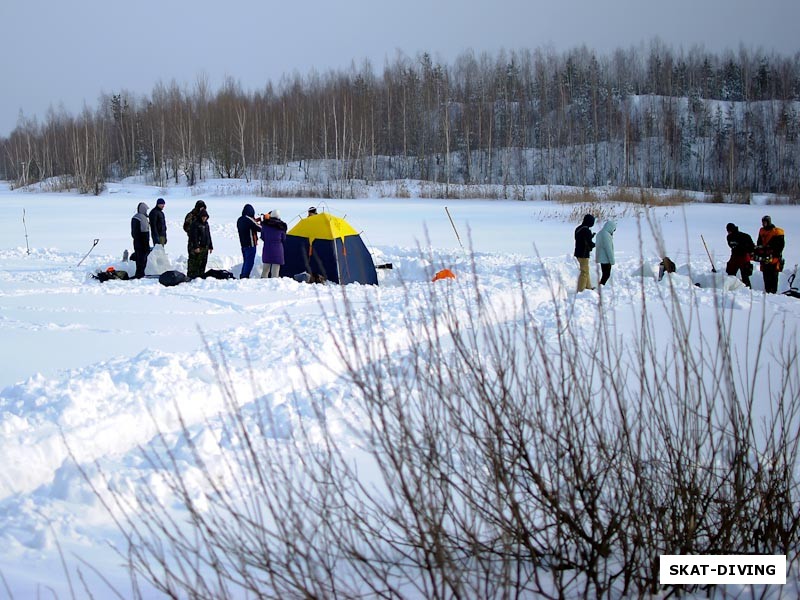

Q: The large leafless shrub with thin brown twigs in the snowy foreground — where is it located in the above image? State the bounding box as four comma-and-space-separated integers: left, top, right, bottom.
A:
83, 255, 800, 598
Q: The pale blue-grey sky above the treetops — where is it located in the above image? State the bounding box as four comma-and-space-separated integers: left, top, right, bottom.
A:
0, 0, 800, 136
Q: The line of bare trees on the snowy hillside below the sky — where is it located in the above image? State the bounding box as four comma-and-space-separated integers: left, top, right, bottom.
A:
0, 40, 800, 195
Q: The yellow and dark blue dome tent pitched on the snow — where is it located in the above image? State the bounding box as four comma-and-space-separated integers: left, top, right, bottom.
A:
281, 213, 378, 285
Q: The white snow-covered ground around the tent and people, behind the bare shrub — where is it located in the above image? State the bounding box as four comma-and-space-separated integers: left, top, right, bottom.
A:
0, 182, 800, 598
